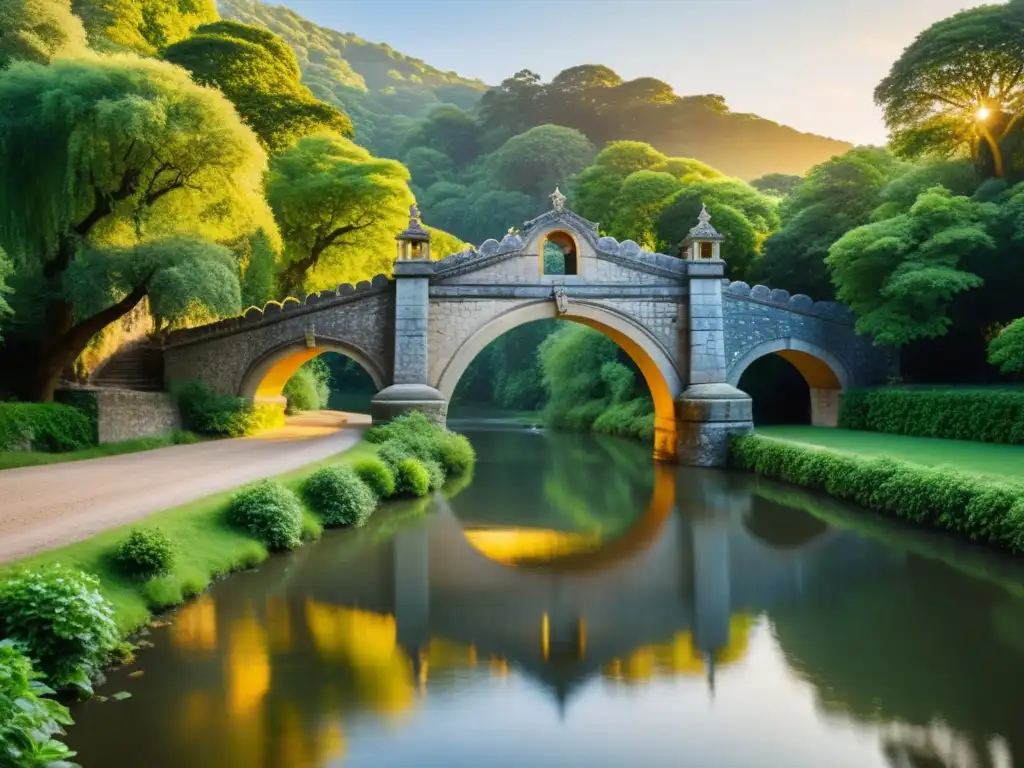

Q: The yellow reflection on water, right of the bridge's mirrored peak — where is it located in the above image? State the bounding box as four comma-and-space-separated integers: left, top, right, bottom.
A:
601, 614, 753, 685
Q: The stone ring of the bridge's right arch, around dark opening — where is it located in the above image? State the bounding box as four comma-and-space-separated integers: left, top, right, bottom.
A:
729, 339, 851, 427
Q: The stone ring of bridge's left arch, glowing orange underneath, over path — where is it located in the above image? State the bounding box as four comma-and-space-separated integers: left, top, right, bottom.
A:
239, 336, 388, 402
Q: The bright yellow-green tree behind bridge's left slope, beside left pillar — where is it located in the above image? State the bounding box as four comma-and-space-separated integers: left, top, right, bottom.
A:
267, 134, 414, 293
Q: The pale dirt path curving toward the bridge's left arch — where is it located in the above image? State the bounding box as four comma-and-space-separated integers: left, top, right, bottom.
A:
0, 411, 370, 563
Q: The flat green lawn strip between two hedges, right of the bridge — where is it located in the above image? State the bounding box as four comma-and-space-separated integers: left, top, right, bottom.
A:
757, 426, 1024, 483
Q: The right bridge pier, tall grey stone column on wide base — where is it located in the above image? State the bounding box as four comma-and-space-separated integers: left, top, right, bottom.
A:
676, 260, 754, 467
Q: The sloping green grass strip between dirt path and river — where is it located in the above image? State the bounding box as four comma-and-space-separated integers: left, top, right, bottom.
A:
0, 442, 376, 634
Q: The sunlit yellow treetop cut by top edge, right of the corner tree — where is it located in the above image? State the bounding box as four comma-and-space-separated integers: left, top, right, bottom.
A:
71, 0, 217, 55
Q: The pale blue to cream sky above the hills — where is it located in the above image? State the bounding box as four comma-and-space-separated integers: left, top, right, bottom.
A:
280, 0, 999, 143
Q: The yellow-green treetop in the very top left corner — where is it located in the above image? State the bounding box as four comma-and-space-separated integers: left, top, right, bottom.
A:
0, 0, 86, 70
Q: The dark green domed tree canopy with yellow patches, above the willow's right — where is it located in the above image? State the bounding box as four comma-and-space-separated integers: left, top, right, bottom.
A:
163, 22, 352, 152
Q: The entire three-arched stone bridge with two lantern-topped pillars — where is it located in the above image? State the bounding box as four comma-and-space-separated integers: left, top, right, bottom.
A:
164, 190, 895, 466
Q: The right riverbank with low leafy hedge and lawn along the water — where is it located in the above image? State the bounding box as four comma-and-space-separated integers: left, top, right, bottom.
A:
729, 430, 1024, 554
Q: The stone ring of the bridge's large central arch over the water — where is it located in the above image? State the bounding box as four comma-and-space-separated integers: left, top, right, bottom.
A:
434, 300, 683, 461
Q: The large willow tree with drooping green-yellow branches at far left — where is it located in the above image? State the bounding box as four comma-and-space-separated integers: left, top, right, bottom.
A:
0, 54, 272, 400
